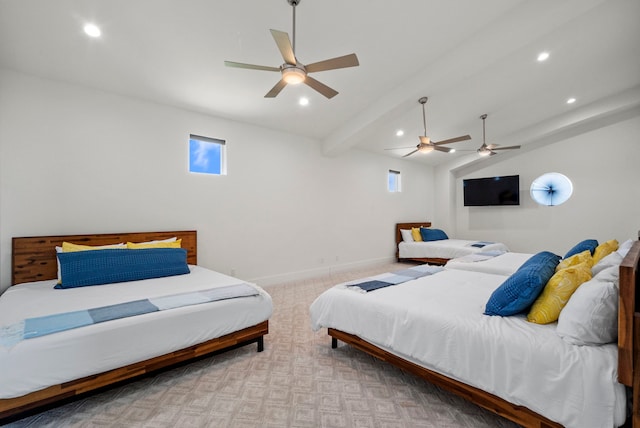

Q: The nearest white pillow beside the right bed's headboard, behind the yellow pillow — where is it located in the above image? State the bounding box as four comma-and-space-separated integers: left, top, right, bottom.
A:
556, 278, 618, 345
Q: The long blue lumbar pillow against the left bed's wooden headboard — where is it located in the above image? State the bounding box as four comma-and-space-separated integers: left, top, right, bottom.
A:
54, 248, 190, 288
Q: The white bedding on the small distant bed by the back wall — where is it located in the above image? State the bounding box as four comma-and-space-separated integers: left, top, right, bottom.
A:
398, 239, 509, 259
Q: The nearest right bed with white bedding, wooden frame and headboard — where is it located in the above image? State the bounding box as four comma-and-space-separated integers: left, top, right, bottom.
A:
310, 241, 640, 428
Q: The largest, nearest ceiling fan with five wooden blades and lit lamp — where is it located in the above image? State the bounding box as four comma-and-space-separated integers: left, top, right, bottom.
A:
224, 0, 360, 98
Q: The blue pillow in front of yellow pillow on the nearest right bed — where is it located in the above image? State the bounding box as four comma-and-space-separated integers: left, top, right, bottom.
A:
484, 251, 560, 317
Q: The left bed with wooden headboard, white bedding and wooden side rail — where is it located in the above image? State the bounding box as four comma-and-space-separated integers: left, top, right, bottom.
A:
0, 231, 272, 422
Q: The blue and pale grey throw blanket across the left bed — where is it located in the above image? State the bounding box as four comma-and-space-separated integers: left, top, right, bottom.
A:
0, 283, 259, 348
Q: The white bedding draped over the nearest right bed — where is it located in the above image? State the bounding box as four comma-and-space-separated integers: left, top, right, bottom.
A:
310, 269, 625, 428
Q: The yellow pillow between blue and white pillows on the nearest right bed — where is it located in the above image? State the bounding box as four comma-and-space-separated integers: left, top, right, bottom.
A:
527, 263, 591, 324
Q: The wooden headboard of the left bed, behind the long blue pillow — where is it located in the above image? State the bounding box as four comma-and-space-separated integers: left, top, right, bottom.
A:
11, 230, 198, 285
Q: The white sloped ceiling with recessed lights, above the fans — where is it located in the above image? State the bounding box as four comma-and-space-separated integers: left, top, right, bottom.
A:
0, 0, 640, 165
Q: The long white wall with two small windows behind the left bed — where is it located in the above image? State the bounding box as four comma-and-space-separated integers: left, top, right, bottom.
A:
0, 70, 433, 290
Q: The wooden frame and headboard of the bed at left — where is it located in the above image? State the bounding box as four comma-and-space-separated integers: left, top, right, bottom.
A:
0, 230, 269, 424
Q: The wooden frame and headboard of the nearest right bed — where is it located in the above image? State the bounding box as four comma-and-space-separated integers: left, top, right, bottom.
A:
328, 239, 640, 428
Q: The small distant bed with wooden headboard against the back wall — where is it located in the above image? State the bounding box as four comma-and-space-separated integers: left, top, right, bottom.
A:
395, 222, 509, 265
